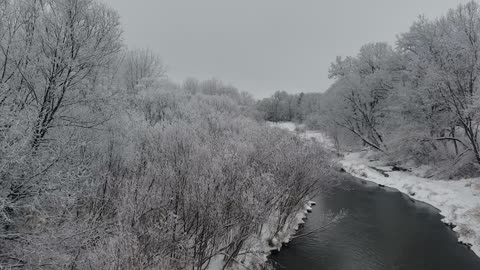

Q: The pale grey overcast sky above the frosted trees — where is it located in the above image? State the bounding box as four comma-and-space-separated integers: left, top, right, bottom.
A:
103, 0, 468, 97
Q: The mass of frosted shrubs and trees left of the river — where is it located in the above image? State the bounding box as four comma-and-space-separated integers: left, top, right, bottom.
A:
0, 0, 329, 269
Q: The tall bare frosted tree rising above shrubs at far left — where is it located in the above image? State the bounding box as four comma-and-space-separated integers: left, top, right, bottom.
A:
1, 0, 121, 148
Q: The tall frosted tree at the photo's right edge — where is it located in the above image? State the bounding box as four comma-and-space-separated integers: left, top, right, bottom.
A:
399, 2, 480, 163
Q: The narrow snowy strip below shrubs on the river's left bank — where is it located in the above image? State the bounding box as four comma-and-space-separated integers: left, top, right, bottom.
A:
206, 201, 316, 270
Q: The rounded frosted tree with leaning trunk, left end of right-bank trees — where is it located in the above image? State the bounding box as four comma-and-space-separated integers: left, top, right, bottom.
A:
330, 43, 401, 151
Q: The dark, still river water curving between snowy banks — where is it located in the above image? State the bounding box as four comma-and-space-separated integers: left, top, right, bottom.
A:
270, 175, 480, 270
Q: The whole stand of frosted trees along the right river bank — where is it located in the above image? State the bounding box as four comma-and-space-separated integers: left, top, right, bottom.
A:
260, 1, 480, 176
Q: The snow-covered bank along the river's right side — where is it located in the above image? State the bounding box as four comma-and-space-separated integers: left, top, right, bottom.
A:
271, 123, 480, 256
